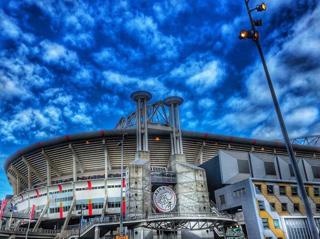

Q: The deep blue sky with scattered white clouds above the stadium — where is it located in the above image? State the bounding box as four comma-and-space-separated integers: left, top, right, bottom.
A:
0, 0, 320, 196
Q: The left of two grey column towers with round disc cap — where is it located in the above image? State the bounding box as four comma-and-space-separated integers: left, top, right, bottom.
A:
131, 91, 152, 152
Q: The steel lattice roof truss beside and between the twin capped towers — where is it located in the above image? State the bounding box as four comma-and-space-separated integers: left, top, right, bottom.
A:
115, 101, 169, 129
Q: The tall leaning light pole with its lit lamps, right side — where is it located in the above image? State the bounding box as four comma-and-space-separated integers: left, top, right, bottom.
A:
239, 0, 319, 239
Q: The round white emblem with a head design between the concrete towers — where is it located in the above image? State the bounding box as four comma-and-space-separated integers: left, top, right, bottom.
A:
153, 186, 177, 212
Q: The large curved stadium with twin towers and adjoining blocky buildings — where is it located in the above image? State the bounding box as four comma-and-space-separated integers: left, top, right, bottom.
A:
0, 91, 320, 239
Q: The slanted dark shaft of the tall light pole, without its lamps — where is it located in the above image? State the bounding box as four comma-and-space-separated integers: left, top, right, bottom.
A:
245, 0, 319, 239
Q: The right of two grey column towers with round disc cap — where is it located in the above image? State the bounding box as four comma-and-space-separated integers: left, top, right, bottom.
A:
164, 96, 183, 155
